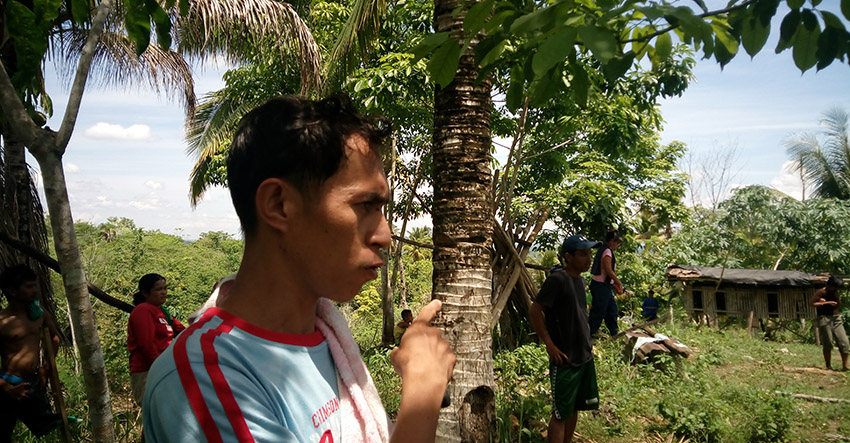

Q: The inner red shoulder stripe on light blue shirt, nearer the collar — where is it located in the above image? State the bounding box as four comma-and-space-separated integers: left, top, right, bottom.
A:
201, 322, 254, 443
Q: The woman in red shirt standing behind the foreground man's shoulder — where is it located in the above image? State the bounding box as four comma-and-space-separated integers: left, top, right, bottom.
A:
127, 274, 186, 406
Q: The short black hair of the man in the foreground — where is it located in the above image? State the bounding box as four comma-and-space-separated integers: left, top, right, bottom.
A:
222, 95, 390, 236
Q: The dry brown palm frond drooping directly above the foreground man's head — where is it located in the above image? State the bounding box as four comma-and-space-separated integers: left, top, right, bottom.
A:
174, 0, 322, 94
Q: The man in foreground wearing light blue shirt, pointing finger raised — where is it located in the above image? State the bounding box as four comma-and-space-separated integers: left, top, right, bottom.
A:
144, 97, 455, 443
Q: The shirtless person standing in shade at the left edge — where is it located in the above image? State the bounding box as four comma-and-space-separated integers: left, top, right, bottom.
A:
0, 264, 62, 443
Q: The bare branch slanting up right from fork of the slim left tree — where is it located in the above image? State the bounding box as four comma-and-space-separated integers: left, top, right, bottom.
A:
56, 0, 112, 150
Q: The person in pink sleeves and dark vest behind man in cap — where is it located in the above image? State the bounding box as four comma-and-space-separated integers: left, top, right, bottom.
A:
590, 229, 623, 336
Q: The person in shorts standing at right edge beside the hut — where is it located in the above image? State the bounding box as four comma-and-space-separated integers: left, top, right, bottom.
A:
812, 275, 850, 371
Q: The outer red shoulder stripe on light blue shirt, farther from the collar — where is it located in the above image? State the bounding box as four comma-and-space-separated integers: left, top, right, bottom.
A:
174, 314, 224, 443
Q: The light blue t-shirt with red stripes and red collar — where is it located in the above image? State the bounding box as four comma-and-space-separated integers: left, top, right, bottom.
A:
143, 308, 342, 443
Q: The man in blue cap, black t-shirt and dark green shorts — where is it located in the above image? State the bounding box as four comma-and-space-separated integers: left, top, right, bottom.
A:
530, 235, 602, 443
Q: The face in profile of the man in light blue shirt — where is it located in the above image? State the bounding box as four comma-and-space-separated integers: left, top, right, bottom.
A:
287, 135, 391, 301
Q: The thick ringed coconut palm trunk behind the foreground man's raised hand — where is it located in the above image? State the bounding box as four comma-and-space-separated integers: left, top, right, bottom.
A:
432, 0, 495, 442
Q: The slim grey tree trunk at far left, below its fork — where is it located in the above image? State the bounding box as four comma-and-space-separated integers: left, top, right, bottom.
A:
36, 150, 115, 442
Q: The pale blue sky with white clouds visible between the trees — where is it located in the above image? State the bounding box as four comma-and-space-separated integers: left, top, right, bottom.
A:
30, 11, 850, 239
